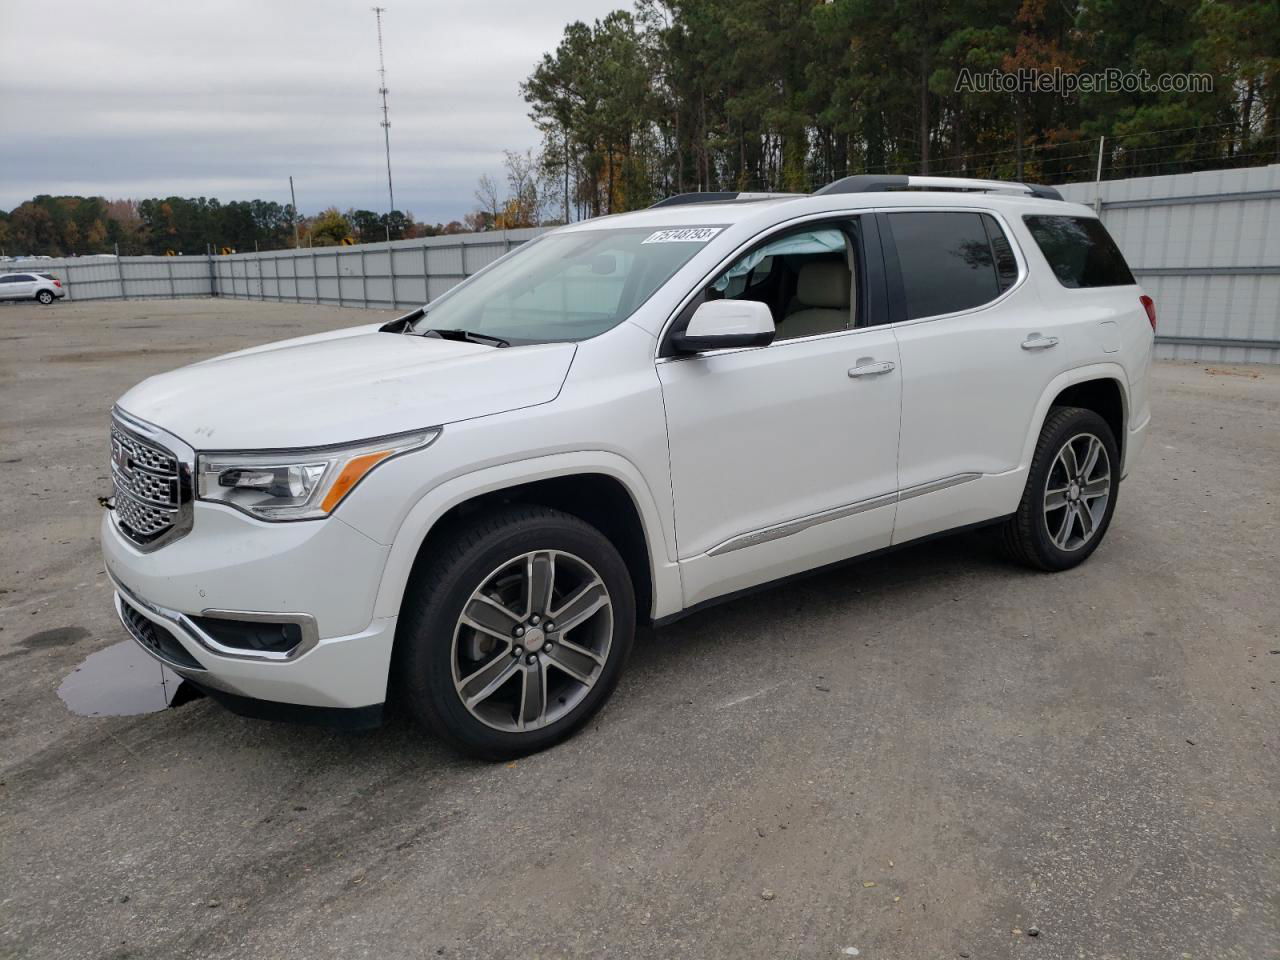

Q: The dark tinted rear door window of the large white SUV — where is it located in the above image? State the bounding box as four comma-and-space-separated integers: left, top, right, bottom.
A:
888, 210, 1018, 320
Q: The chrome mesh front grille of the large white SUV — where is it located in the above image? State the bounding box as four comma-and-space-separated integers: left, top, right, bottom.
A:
111, 421, 189, 545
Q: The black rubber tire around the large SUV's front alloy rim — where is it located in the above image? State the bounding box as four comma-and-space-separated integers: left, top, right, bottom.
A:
392, 506, 636, 760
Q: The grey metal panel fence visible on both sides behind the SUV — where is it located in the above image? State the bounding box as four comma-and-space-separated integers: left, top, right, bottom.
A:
0, 164, 1280, 364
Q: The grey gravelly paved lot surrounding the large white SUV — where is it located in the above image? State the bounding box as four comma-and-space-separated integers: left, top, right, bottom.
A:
0, 300, 1280, 960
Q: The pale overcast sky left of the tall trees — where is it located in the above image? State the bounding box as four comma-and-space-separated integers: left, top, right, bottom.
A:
0, 0, 619, 221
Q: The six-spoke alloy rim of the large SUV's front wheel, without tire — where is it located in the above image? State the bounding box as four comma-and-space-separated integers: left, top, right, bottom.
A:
451, 550, 613, 732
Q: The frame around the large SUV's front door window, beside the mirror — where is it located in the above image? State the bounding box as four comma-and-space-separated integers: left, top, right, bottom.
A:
654, 207, 892, 364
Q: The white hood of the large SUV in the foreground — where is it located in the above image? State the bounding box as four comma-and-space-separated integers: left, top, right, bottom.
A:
118, 324, 576, 451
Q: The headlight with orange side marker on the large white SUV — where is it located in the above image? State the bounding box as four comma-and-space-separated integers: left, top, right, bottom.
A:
196, 429, 440, 520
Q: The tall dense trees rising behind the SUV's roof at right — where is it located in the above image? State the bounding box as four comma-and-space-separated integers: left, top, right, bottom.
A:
504, 0, 1280, 219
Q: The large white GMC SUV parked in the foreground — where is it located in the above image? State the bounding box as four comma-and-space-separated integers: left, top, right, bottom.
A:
102, 177, 1156, 756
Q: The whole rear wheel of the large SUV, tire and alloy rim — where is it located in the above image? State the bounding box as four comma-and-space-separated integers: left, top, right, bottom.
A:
1004, 407, 1120, 571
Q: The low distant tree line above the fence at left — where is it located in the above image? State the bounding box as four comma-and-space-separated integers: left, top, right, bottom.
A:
0, 195, 481, 257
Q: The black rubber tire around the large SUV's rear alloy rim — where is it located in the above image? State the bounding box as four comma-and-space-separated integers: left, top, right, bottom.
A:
1001, 407, 1120, 571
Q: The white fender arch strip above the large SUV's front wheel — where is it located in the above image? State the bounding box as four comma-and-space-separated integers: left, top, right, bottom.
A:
375, 453, 682, 620
